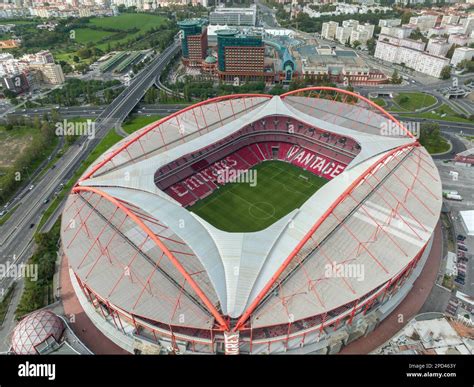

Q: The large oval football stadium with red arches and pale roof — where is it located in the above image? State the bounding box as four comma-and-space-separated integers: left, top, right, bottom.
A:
61, 87, 442, 354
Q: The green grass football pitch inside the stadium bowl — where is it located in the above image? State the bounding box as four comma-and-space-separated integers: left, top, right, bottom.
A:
188, 160, 327, 232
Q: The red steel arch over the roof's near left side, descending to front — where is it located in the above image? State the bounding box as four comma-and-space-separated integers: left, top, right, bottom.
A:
72, 186, 229, 330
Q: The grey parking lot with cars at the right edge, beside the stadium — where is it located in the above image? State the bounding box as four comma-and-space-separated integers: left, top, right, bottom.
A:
436, 160, 474, 296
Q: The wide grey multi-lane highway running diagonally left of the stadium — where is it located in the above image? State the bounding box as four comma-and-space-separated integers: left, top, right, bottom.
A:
0, 41, 180, 342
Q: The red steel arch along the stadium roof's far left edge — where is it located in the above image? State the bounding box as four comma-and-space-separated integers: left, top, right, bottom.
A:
79, 94, 273, 182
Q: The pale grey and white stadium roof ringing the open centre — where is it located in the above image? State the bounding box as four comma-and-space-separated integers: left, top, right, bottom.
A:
62, 90, 442, 328
